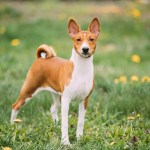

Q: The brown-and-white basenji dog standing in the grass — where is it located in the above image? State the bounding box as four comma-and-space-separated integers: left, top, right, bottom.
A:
10, 18, 100, 145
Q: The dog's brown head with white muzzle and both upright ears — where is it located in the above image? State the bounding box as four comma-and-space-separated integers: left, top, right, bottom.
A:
68, 18, 100, 58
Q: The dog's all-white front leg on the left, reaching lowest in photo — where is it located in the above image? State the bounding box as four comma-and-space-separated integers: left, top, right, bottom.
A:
61, 96, 70, 145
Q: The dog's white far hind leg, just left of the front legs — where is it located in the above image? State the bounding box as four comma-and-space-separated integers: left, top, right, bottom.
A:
50, 93, 60, 123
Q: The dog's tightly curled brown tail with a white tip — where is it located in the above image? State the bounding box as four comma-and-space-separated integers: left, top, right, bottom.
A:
36, 44, 56, 58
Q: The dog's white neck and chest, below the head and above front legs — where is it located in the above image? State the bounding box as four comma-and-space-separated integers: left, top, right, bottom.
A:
64, 49, 94, 99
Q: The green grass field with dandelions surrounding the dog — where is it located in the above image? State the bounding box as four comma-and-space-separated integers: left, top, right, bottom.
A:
0, 1, 150, 150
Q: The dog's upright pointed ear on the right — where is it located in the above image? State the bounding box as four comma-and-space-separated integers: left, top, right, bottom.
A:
89, 18, 100, 36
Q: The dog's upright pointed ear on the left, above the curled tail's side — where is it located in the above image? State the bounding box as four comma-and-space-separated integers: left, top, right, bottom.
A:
68, 19, 81, 37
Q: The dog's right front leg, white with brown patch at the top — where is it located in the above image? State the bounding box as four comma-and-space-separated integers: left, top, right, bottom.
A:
76, 100, 86, 139
